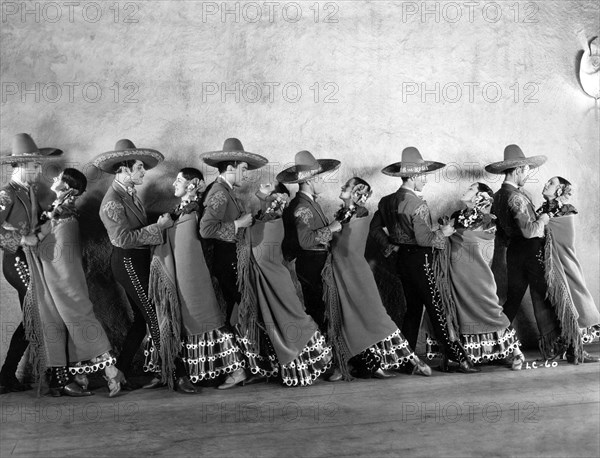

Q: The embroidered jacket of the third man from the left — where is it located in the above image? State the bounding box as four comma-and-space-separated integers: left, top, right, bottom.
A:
200, 176, 244, 243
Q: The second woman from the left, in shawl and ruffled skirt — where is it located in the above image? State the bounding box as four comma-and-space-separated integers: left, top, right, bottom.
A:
146, 167, 244, 392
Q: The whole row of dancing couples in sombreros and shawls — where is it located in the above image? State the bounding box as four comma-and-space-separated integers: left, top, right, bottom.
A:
0, 134, 600, 397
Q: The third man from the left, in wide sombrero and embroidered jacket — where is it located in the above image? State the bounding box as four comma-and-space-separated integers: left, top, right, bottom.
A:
200, 138, 271, 389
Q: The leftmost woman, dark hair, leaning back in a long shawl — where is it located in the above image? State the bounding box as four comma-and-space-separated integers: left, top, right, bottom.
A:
25, 168, 121, 397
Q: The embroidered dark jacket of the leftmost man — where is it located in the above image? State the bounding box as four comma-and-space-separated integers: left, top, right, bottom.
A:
0, 181, 41, 253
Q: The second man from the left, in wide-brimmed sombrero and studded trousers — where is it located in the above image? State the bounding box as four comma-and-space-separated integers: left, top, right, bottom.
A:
93, 139, 196, 393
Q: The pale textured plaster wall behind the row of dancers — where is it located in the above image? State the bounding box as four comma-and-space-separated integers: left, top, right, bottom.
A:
0, 1, 600, 364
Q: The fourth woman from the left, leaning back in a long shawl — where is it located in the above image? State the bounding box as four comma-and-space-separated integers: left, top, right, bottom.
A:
323, 177, 431, 381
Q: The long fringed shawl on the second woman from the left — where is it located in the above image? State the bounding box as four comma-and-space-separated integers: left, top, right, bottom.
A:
148, 212, 225, 388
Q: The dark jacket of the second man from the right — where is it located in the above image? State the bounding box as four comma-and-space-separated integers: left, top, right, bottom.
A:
370, 188, 446, 257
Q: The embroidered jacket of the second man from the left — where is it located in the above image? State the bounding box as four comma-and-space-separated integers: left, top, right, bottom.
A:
100, 182, 163, 249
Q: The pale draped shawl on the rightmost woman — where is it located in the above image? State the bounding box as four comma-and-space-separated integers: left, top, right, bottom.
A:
544, 215, 584, 358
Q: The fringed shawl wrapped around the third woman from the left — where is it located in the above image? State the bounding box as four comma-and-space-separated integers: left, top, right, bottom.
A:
237, 218, 317, 365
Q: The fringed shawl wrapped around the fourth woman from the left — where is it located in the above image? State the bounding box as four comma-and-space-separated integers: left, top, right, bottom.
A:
322, 217, 398, 380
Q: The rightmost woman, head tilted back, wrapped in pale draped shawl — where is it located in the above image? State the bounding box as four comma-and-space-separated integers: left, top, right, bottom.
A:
536, 176, 600, 363
